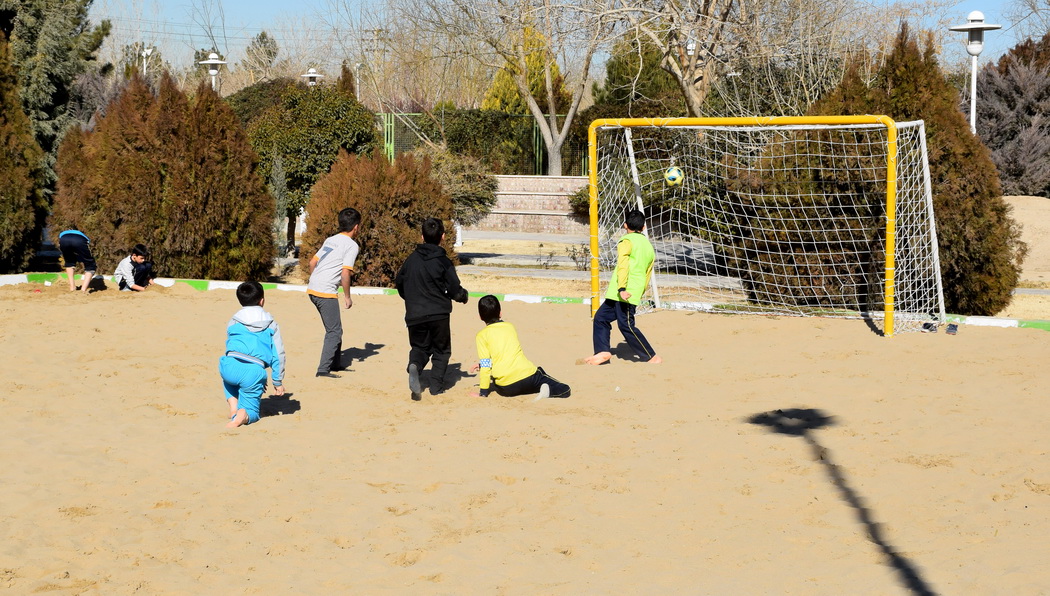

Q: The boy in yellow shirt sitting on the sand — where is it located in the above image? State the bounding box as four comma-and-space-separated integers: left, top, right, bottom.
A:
470, 294, 570, 399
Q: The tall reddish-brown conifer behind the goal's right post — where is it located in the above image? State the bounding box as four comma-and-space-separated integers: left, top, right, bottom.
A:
811, 24, 1027, 315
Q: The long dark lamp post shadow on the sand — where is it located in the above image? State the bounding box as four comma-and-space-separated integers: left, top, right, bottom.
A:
748, 408, 936, 596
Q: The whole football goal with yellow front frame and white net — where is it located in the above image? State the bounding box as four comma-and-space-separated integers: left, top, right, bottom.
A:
589, 116, 945, 337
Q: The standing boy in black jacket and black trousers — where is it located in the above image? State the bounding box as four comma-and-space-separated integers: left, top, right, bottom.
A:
394, 217, 467, 402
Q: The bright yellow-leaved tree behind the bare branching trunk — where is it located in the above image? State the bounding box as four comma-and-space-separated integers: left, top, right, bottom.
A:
481, 28, 572, 114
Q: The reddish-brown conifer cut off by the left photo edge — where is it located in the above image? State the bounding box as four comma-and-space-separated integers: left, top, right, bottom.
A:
0, 33, 47, 273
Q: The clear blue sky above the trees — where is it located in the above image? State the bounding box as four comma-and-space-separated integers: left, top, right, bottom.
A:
92, 0, 1017, 68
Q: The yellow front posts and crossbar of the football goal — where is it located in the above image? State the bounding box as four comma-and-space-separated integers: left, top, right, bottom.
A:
587, 115, 897, 337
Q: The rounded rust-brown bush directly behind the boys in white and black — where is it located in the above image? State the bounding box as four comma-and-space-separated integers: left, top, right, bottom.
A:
299, 151, 456, 288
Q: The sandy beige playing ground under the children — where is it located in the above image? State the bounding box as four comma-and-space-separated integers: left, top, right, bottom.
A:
0, 199, 1050, 595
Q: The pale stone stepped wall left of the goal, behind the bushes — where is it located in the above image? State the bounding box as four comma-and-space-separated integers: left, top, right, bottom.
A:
467, 176, 590, 235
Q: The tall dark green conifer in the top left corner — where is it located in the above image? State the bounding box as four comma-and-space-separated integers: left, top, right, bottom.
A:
0, 0, 109, 193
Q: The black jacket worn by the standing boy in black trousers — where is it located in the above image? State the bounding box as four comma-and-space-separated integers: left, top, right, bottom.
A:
394, 243, 467, 325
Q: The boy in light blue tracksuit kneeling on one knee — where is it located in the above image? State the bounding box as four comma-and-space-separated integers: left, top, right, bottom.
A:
218, 281, 285, 428
